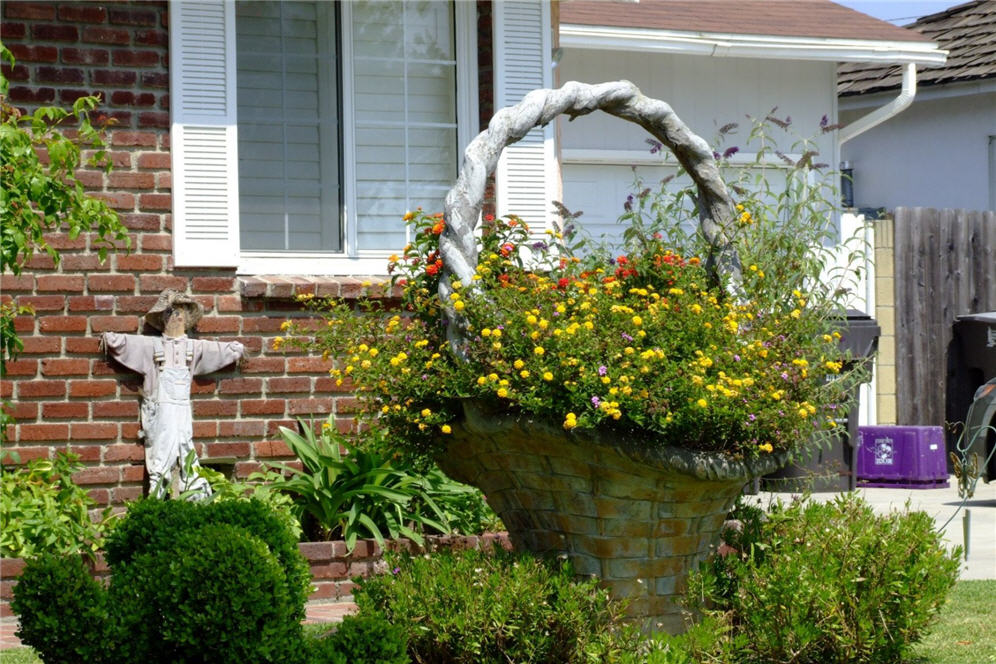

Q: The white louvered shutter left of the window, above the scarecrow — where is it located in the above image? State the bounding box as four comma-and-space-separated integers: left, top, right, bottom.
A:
169, 0, 239, 267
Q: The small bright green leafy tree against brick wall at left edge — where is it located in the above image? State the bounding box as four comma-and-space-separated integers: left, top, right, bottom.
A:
0, 43, 129, 441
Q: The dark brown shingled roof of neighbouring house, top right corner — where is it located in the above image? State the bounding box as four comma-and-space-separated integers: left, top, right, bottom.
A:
837, 0, 996, 96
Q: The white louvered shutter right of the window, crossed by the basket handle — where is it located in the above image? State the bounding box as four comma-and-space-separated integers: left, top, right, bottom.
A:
493, 0, 559, 234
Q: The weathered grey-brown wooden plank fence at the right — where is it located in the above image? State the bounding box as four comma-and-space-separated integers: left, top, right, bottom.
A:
894, 208, 996, 430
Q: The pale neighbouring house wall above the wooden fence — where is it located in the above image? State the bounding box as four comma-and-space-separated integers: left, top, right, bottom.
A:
841, 91, 996, 210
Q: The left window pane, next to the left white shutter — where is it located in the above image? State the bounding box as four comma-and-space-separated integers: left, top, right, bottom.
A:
236, 1, 342, 251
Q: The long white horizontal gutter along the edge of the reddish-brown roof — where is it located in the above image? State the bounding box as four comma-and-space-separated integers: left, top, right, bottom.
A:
560, 23, 948, 65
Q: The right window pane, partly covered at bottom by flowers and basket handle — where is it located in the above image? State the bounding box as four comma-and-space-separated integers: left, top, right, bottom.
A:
350, 0, 457, 251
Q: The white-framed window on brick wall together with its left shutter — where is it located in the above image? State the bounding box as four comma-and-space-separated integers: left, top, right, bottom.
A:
171, 0, 476, 273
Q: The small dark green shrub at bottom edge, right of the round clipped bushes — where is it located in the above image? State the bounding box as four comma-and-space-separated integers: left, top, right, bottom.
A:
309, 613, 411, 664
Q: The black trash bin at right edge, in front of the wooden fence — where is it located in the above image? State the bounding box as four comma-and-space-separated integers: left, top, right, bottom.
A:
945, 311, 996, 481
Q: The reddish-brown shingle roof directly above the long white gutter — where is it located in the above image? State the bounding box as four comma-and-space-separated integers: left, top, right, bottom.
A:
560, 0, 929, 42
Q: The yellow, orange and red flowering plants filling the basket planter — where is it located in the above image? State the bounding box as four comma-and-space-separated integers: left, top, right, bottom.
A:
278, 84, 864, 461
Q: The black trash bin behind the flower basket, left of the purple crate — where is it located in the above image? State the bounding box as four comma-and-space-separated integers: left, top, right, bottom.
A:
761, 309, 882, 492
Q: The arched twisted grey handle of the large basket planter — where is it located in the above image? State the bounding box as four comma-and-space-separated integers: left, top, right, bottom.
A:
439, 81, 740, 348
